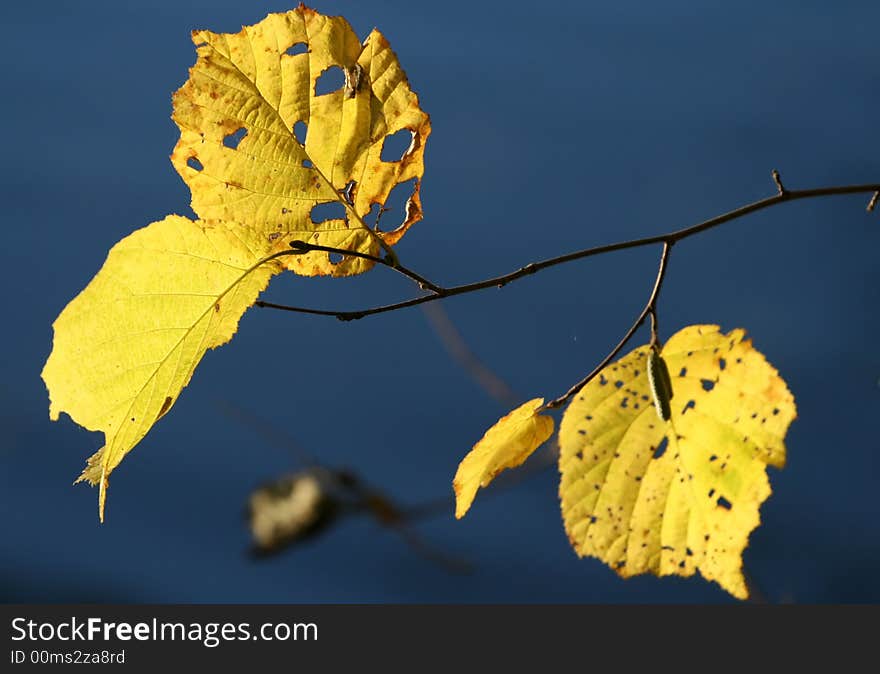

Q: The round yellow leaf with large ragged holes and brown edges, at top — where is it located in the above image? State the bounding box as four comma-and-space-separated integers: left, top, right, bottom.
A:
171, 5, 430, 276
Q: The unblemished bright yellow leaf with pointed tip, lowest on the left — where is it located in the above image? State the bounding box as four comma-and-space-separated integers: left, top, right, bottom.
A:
42, 215, 282, 519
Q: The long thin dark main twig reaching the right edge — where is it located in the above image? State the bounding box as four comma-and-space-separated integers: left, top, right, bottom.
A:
255, 183, 880, 321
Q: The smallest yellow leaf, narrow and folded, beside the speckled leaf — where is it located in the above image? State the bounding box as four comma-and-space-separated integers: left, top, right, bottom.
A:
452, 398, 553, 519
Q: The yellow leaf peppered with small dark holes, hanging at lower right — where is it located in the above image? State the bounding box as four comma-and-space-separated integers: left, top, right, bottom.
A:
559, 325, 796, 598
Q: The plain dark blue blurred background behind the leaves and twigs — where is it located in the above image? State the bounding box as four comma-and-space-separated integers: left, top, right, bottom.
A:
0, 0, 880, 602
